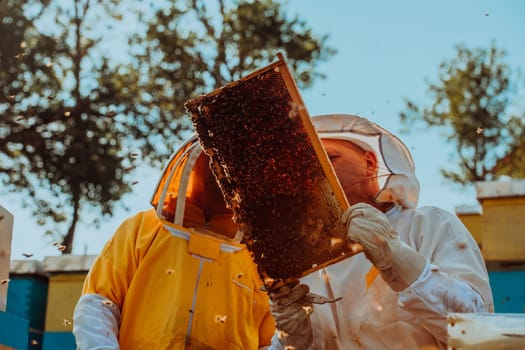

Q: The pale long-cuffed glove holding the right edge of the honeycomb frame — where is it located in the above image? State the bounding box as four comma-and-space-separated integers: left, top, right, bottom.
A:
342, 203, 427, 292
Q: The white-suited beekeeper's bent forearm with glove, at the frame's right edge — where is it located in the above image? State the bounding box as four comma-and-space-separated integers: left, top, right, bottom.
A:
343, 203, 486, 343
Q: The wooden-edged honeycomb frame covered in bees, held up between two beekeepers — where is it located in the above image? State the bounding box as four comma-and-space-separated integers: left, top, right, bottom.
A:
185, 54, 361, 289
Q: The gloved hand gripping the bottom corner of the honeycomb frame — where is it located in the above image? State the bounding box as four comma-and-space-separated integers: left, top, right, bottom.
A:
270, 284, 313, 349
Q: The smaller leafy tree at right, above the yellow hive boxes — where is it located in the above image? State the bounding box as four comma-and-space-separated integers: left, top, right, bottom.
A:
400, 43, 525, 185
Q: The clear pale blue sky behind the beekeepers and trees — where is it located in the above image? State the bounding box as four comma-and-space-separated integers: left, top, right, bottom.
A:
5, 0, 525, 260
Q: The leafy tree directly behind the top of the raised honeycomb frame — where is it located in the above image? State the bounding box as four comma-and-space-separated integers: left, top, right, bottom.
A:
132, 0, 336, 158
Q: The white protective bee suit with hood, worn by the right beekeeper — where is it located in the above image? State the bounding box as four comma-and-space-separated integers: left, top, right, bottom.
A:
296, 115, 493, 350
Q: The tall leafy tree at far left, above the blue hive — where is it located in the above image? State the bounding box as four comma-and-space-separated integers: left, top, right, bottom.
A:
0, 0, 139, 253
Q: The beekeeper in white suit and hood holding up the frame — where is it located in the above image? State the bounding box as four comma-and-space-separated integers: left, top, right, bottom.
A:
271, 115, 493, 350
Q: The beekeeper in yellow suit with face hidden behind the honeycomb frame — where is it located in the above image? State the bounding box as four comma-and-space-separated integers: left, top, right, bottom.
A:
73, 137, 274, 350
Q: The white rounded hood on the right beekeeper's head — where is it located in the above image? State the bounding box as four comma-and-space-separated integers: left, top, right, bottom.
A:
312, 114, 419, 208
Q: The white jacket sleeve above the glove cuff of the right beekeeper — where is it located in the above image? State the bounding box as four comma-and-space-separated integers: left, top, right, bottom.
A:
398, 207, 493, 344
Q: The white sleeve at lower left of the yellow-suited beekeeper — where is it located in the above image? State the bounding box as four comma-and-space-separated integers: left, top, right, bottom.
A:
73, 294, 120, 350
